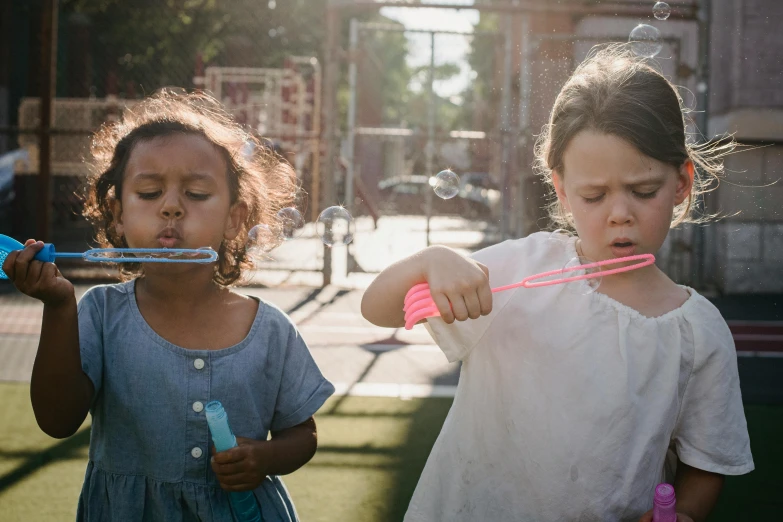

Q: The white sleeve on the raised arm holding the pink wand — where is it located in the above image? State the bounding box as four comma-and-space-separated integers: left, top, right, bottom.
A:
425, 236, 533, 362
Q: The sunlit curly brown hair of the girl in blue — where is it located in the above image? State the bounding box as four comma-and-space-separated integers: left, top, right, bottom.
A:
83, 89, 299, 286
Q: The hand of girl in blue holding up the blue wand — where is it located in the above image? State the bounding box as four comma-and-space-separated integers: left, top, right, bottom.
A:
3, 239, 74, 306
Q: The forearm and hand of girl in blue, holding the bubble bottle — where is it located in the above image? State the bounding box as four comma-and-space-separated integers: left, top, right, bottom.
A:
212, 417, 318, 491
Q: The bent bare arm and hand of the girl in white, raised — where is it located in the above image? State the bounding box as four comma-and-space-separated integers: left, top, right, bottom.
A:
362, 246, 492, 328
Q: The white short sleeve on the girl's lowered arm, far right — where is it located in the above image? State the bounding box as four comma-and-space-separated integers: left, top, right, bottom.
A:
673, 300, 754, 475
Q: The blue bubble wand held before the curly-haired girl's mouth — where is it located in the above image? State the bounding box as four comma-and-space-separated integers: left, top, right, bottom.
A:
0, 234, 217, 279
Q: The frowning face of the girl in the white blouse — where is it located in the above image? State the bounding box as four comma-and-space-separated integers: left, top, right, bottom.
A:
554, 130, 693, 261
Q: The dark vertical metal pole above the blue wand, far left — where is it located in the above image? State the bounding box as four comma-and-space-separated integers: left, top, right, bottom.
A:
36, 0, 57, 241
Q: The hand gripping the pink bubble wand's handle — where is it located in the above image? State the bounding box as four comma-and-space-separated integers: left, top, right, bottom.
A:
426, 247, 492, 324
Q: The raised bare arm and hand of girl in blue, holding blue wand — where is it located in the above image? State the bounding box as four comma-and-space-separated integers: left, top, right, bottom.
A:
3, 239, 93, 439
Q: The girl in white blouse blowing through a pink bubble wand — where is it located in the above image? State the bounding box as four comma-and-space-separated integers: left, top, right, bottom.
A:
362, 47, 753, 522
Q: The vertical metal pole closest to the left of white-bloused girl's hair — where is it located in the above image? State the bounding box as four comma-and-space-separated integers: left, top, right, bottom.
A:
517, 13, 533, 236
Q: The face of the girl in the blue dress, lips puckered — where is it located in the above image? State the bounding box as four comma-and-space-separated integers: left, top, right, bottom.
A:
114, 134, 245, 255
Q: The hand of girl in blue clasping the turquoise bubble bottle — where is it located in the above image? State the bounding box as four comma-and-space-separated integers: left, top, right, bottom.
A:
211, 437, 268, 491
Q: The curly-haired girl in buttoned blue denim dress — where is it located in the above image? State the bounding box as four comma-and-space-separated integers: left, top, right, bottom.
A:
3, 91, 334, 522
